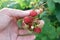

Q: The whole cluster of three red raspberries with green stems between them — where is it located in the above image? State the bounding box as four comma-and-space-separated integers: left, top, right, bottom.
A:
23, 10, 41, 33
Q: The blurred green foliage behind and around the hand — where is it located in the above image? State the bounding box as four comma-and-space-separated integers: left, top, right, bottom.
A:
0, 0, 60, 40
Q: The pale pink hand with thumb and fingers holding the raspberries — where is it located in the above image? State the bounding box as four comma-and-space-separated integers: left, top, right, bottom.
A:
0, 8, 44, 40
